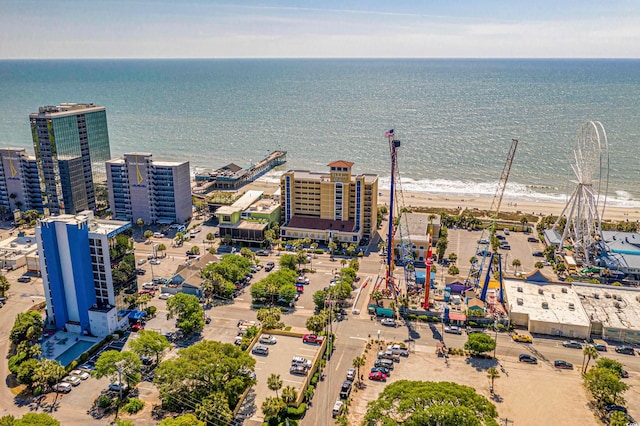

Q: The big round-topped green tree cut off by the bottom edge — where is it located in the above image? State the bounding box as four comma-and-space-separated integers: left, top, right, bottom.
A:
363, 380, 498, 426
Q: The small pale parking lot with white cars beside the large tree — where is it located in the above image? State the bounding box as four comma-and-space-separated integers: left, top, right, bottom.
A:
251, 335, 321, 421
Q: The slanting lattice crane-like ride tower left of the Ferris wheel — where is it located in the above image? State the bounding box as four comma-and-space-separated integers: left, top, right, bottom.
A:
467, 139, 518, 302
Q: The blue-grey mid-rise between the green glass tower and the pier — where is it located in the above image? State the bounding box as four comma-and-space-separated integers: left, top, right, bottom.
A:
106, 152, 192, 224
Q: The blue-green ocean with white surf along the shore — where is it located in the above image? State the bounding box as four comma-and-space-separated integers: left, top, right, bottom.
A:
0, 59, 640, 207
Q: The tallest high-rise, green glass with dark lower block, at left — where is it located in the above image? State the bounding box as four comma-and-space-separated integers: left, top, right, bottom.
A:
29, 103, 111, 215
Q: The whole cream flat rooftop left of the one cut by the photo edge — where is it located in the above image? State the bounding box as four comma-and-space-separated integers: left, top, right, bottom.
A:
504, 279, 590, 327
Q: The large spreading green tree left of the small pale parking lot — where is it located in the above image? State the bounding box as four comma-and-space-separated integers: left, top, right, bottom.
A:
154, 340, 256, 411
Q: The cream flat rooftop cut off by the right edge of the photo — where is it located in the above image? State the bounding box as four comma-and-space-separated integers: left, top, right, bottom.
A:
573, 282, 640, 330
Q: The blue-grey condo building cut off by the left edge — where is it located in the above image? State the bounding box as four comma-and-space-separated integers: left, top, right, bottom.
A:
0, 148, 44, 215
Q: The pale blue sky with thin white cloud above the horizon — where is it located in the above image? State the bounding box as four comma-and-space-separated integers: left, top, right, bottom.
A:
0, 0, 640, 59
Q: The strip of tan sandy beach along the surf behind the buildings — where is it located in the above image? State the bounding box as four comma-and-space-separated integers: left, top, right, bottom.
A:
244, 181, 640, 225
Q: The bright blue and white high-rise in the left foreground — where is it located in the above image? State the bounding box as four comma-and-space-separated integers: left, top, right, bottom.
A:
36, 211, 138, 336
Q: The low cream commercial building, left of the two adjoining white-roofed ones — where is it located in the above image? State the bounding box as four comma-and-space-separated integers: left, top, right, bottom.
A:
504, 271, 591, 339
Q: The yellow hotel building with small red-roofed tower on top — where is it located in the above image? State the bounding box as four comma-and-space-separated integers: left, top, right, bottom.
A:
280, 160, 378, 243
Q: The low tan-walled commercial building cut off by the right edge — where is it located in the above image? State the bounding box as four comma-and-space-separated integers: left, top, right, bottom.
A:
573, 282, 640, 344
